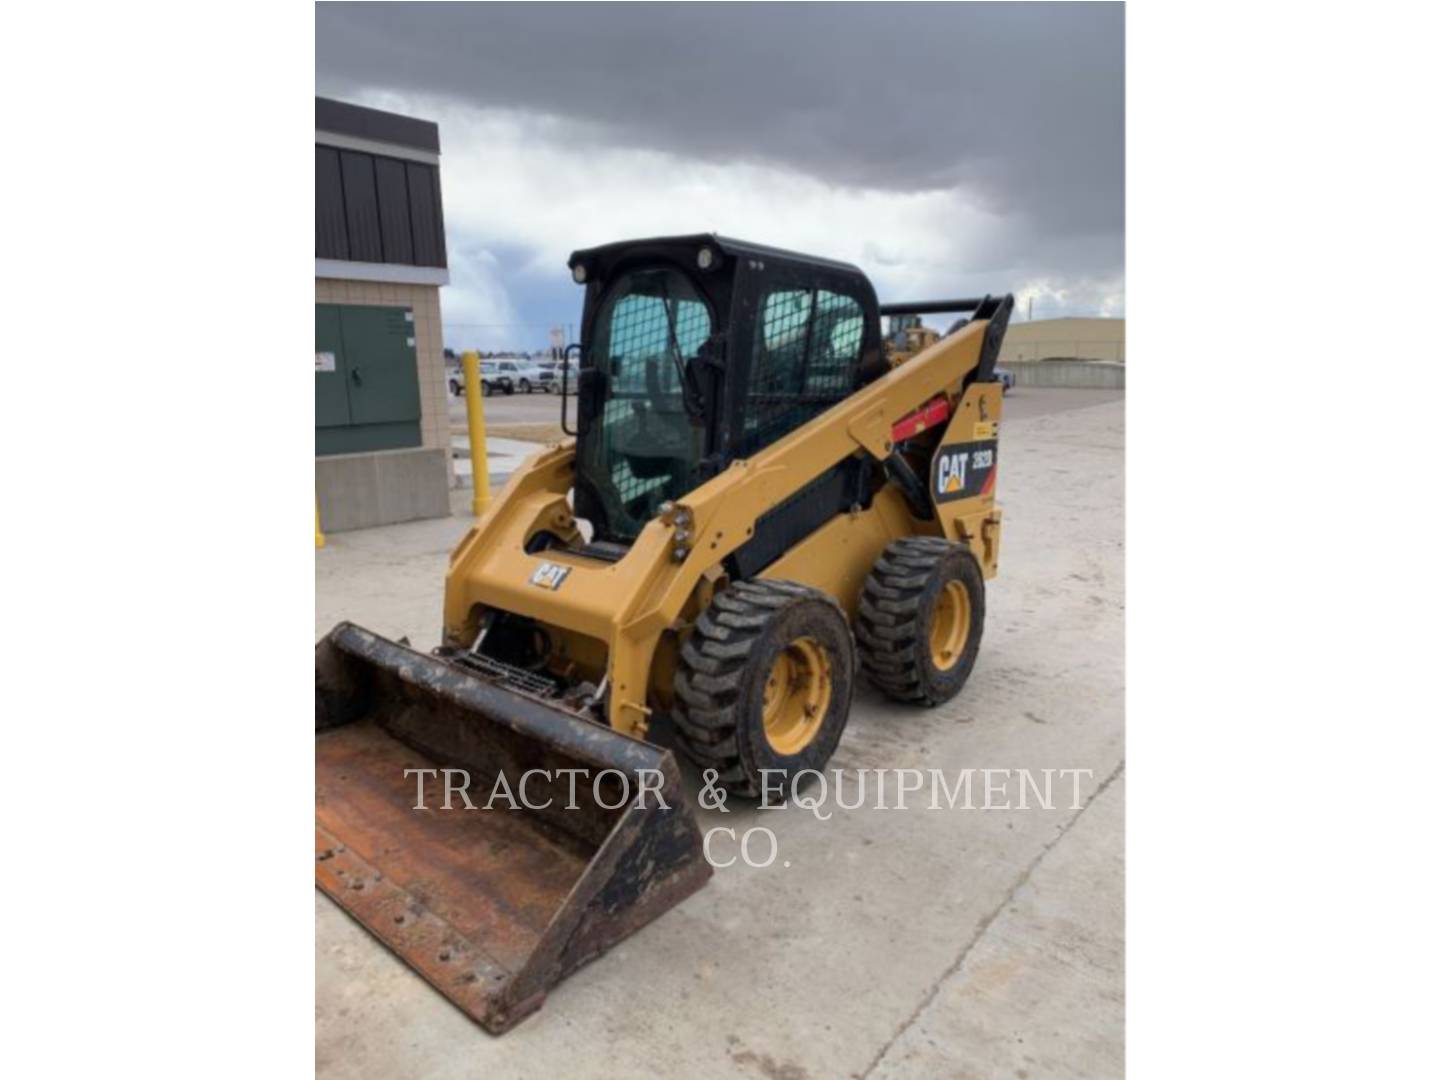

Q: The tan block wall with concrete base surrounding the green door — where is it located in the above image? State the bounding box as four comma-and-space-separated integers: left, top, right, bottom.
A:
315, 278, 454, 533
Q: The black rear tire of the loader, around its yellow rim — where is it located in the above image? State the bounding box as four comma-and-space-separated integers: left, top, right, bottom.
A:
855, 536, 985, 706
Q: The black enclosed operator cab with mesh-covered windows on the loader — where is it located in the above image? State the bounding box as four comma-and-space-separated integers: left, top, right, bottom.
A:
569, 235, 886, 544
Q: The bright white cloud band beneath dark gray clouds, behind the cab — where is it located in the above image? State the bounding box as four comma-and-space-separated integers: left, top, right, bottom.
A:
351, 92, 1123, 336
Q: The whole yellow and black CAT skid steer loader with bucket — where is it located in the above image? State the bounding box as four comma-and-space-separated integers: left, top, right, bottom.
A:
315, 235, 1014, 1032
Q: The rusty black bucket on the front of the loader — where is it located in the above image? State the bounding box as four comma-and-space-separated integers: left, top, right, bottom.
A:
315, 622, 711, 1034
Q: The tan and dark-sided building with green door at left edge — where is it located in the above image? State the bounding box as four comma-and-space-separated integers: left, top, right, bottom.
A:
315, 98, 451, 531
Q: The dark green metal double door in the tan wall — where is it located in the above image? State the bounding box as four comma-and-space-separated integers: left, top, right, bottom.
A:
315, 304, 420, 454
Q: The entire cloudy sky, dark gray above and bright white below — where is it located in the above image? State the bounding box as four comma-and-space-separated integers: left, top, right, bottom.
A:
315, 3, 1125, 347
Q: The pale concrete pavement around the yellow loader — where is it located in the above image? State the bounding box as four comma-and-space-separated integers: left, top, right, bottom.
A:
315, 389, 1125, 1080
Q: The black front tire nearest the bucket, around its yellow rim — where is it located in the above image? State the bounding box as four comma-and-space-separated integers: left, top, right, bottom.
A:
674, 580, 855, 802
